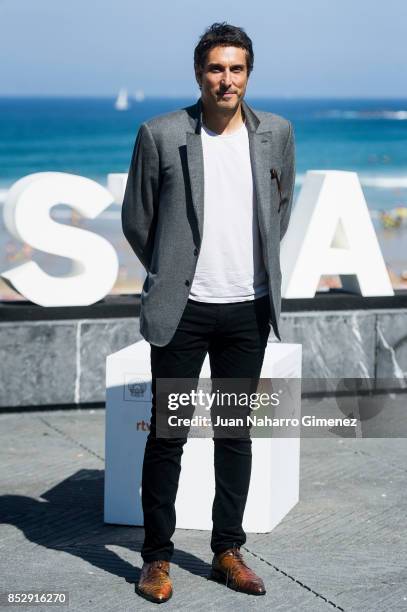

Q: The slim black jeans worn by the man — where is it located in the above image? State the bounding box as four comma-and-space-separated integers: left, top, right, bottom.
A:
141, 296, 270, 561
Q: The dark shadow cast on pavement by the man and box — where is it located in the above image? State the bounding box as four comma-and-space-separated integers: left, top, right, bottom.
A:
0, 469, 210, 583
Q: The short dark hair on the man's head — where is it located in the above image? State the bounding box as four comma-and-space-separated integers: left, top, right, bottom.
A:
194, 21, 254, 74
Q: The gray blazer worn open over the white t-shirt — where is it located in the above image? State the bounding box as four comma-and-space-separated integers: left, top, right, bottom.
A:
122, 99, 295, 346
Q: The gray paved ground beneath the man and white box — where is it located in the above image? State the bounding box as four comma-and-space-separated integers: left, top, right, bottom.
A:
0, 395, 407, 612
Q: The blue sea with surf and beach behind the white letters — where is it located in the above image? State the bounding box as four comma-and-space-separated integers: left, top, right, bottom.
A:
0, 96, 407, 297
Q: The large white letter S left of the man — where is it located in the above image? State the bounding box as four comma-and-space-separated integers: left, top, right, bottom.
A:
0, 172, 119, 306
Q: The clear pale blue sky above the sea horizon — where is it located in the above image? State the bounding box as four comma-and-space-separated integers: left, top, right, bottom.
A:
0, 0, 407, 97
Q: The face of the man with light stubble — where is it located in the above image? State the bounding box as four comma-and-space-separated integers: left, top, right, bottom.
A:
196, 47, 249, 113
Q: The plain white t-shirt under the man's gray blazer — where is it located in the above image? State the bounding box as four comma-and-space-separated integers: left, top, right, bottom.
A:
189, 124, 268, 303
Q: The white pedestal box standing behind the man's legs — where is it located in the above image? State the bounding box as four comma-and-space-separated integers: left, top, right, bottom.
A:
104, 340, 302, 533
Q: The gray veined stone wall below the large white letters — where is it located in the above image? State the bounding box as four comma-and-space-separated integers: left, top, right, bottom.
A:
0, 308, 407, 409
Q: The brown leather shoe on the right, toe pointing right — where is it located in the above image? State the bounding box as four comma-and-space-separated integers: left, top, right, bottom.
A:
210, 547, 266, 595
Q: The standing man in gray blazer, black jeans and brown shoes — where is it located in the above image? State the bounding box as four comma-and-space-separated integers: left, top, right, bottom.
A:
122, 23, 295, 602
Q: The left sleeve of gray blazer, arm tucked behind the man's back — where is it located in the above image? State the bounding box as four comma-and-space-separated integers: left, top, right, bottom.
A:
121, 123, 160, 271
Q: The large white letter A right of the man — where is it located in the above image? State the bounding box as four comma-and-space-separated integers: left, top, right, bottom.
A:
281, 170, 394, 298
